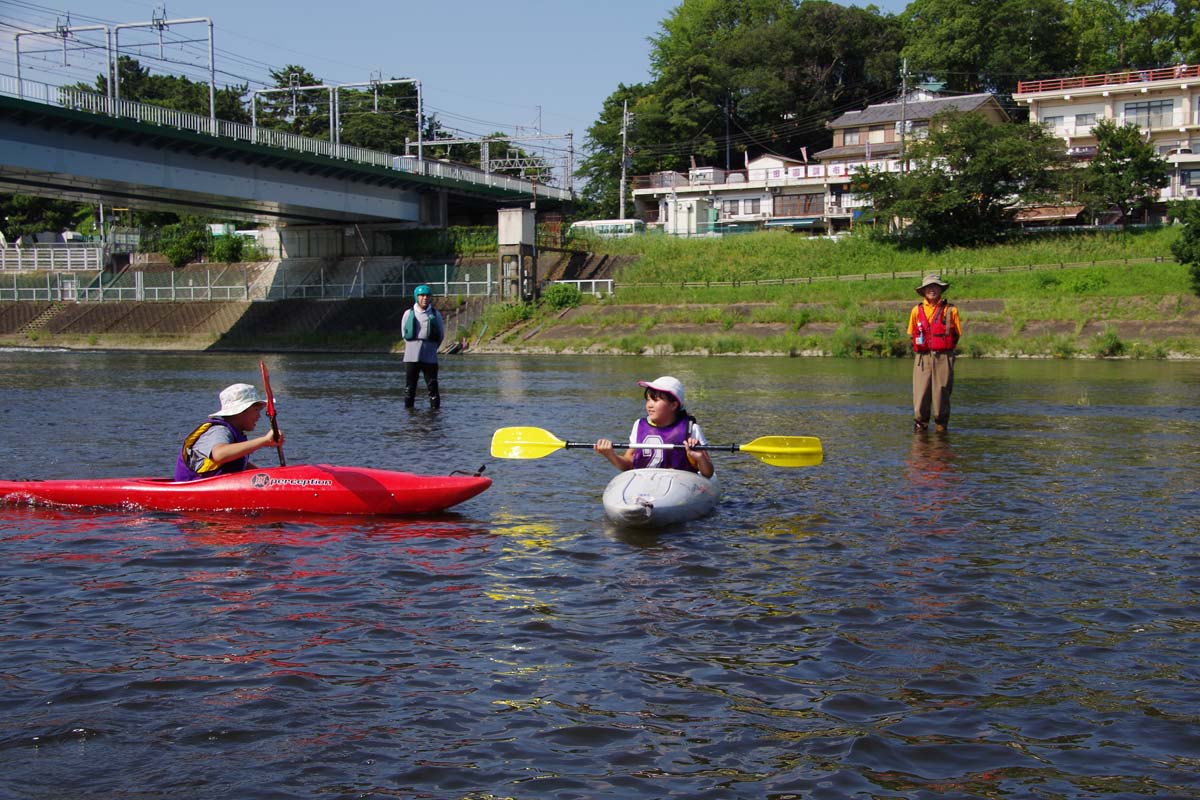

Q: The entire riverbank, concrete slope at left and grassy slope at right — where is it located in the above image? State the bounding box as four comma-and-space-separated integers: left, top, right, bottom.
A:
0, 228, 1200, 359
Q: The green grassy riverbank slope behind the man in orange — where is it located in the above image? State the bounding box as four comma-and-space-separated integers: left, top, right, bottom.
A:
474, 228, 1200, 359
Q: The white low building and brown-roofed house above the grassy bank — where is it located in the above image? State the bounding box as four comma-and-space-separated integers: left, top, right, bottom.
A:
632, 89, 1008, 236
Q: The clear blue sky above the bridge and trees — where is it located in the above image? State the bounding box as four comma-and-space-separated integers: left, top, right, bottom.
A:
0, 0, 906, 173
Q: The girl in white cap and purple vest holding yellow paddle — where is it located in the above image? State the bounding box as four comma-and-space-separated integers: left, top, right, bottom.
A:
595, 375, 713, 477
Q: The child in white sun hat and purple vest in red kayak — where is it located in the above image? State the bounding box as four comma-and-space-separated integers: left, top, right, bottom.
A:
175, 384, 283, 481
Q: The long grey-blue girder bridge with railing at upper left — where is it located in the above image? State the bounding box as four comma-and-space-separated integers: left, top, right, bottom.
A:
0, 77, 571, 244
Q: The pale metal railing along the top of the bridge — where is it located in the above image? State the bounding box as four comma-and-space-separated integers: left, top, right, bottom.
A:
0, 76, 571, 200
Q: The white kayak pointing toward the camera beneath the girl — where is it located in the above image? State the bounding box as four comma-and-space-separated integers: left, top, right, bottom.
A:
604, 469, 721, 528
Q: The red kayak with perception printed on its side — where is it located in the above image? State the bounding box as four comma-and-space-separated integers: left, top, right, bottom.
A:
0, 464, 492, 516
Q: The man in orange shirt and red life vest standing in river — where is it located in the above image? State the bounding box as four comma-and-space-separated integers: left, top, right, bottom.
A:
908, 275, 962, 433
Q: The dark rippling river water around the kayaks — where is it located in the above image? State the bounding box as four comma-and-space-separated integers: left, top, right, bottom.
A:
0, 351, 1200, 800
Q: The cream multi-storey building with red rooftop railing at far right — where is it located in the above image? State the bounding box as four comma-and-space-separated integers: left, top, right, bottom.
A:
1013, 65, 1200, 200
